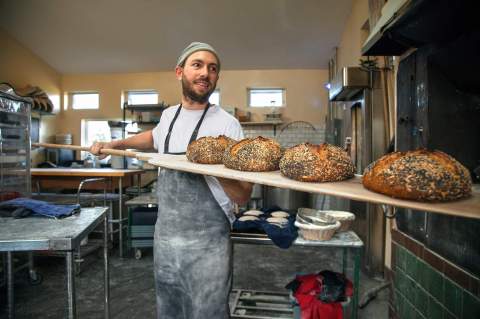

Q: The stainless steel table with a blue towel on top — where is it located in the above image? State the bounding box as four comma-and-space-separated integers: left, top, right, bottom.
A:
0, 207, 110, 318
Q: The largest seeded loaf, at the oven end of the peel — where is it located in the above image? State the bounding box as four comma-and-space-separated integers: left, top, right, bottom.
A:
363, 149, 472, 201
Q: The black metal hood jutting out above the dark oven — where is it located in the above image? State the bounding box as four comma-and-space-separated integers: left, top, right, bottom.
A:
362, 0, 480, 56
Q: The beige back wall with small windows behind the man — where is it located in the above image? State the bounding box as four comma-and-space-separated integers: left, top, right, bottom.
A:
57, 70, 328, 144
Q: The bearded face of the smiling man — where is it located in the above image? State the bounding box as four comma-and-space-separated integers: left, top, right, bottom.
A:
175, 51, 218, 103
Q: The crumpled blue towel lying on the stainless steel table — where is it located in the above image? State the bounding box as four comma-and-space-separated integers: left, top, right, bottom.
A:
0, 197, 80, 218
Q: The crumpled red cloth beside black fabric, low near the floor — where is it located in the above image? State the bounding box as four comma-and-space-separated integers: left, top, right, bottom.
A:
294, 275, 353, 319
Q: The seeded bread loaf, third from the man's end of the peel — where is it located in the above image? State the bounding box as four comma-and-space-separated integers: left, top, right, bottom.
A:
280, 143, 355, 182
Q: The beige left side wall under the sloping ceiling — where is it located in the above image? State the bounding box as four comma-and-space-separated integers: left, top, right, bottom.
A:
0, 29, 61, 163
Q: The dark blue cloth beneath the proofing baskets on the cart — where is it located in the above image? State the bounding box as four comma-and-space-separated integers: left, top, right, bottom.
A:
233, 208, 298, 249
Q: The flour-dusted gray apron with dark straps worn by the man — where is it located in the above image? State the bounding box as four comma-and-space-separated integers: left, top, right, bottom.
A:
154, 106, 232, 319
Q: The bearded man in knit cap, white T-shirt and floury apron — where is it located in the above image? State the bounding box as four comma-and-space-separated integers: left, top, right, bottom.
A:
91, 42, 252, 319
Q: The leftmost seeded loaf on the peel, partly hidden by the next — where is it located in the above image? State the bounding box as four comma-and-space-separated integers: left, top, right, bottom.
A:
187, 135, 236, 164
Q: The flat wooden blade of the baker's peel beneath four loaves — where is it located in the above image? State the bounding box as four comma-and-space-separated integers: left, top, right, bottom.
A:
144, 153, 480, 219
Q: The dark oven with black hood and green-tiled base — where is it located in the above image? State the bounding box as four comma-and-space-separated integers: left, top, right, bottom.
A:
363, 0, 480, 318
